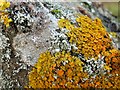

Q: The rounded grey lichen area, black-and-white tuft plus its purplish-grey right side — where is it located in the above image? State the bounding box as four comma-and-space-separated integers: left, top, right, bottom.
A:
11, 2, 48, 32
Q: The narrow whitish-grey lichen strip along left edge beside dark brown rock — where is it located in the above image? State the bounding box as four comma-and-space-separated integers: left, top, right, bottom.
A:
0, 25, 11, 88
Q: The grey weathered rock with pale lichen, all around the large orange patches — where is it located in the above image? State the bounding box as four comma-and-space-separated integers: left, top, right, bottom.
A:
0, 1, 120, 88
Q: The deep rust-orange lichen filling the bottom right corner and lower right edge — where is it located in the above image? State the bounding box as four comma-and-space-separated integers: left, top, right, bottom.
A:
81, 48, 120, 89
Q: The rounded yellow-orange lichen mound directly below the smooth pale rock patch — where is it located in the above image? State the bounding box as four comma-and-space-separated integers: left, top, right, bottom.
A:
26, 51, 87, 88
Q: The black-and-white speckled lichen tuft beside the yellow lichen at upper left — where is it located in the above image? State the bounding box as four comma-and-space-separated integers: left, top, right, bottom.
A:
11, 3, 33, 32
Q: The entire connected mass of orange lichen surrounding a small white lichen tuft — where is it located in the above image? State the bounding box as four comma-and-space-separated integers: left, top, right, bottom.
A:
27, 16, 120, 89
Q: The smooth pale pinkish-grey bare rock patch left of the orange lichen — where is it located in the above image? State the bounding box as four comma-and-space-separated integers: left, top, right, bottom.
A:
13, 29, 50, 65
